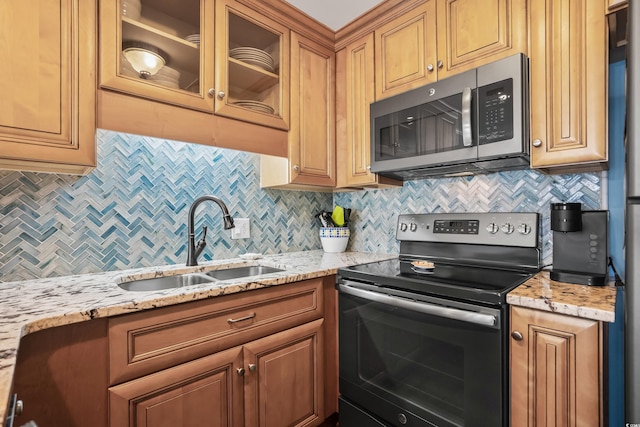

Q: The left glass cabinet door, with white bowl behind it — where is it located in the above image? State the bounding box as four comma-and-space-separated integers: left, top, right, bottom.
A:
100, 0, 214, 111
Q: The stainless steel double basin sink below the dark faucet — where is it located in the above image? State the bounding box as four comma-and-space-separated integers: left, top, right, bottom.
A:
118, 265, 284, 291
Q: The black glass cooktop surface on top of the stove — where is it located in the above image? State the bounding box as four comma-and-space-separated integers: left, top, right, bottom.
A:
338, 258, 533, 305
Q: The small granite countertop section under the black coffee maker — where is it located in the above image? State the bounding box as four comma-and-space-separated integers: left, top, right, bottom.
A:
507, 271, 617, 322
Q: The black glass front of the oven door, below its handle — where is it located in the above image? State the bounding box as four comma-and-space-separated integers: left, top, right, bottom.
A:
340, 294, 504, 426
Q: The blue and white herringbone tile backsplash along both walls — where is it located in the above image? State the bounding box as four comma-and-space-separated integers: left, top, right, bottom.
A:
0, 130, 601, 282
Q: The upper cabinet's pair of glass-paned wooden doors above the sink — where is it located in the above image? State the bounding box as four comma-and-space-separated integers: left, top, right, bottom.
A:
100, 0, 289, 129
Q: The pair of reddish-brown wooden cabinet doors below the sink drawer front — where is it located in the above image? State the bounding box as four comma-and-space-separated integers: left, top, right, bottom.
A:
109, 319, 324, 427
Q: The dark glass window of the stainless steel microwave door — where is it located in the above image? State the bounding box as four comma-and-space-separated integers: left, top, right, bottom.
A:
375, 94, 464, 160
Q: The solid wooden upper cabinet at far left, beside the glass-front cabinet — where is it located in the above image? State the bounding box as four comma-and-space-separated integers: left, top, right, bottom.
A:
0, 0, 97, 174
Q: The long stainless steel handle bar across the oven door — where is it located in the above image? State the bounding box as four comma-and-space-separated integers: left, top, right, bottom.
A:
338, 283, 496, 326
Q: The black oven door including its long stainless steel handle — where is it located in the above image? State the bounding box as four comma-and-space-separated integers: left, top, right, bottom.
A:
337, 279, 508, 427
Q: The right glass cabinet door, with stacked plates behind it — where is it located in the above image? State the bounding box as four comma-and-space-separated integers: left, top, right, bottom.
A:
214, 0, 289, 129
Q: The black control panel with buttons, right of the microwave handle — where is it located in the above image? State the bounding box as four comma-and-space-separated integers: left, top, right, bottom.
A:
478, 79, 513, 144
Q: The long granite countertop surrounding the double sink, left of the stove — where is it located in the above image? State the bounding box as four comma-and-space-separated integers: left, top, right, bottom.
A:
0, 250, 397, 424
